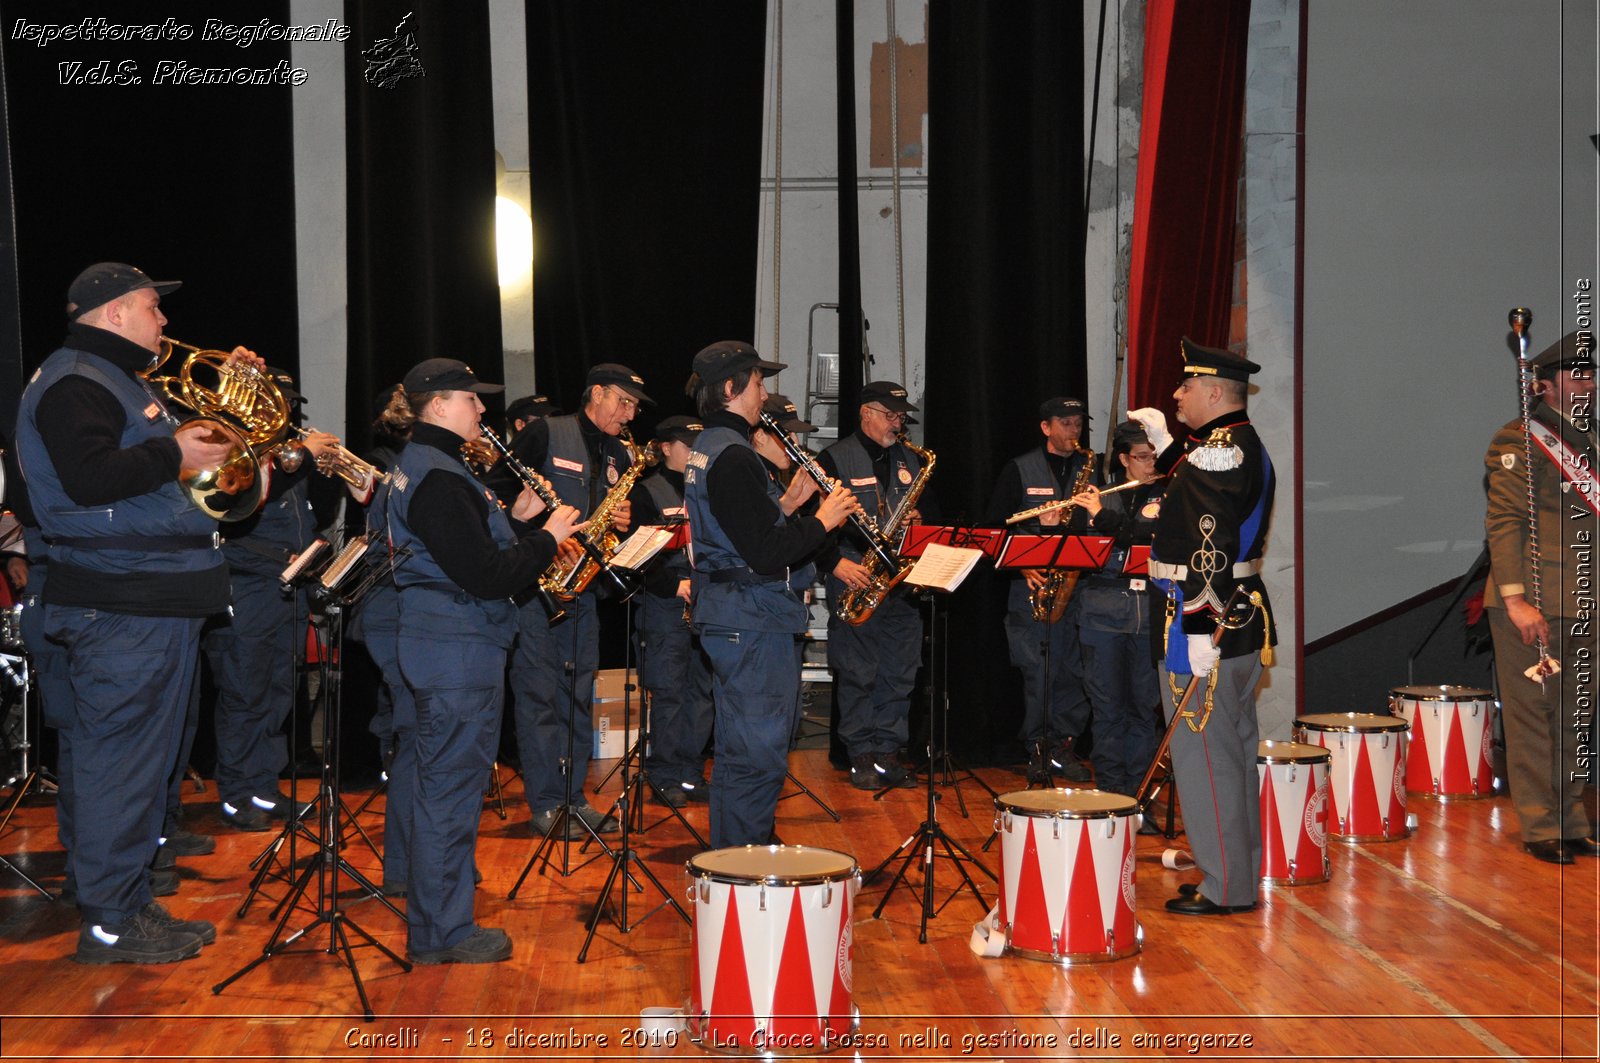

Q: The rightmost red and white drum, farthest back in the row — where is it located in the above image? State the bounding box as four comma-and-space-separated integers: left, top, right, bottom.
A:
1389, 687, 1494, 800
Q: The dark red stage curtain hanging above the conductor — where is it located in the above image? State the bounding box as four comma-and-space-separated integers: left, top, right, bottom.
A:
1115, 0, 1250, 419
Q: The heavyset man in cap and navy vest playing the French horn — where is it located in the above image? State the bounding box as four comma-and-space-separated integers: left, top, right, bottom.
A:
16, 263, 262, 964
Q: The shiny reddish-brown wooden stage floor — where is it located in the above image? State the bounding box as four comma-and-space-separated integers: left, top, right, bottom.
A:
0, 751, 1600, 1060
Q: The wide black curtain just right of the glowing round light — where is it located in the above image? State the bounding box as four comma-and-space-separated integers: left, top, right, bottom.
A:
528, 0, 766, 439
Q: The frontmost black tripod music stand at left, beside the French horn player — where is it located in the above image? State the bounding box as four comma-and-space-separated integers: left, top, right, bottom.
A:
211, 576, 411, 1021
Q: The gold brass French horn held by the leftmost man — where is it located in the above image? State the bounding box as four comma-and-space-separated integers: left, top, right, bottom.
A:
142, 336, 290, 522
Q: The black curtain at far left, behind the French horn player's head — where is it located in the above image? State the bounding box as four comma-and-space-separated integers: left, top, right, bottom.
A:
0, 0, 300, 389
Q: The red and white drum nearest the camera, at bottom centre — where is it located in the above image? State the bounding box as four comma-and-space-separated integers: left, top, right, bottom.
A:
685, 845, 861, 1053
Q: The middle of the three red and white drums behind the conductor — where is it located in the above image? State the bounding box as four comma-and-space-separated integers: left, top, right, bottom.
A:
1294, 712, 1411, 842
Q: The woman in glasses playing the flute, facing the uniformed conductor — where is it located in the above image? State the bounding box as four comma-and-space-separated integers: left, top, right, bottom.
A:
1072, 421, 1165, 800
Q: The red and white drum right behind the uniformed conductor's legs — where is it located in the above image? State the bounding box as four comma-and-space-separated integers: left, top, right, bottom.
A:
1256, 741, 1331, 885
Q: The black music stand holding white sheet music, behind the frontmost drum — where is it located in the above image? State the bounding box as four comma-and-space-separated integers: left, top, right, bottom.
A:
864, 544, 998, 945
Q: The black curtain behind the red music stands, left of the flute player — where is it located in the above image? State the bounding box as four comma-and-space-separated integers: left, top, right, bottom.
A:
926, 0, 1088, 759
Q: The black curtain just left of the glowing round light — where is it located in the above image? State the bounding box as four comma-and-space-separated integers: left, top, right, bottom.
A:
344, 0, 504, 445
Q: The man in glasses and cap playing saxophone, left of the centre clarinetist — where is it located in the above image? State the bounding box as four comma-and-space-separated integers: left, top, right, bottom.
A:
510, 362, 653, 839
